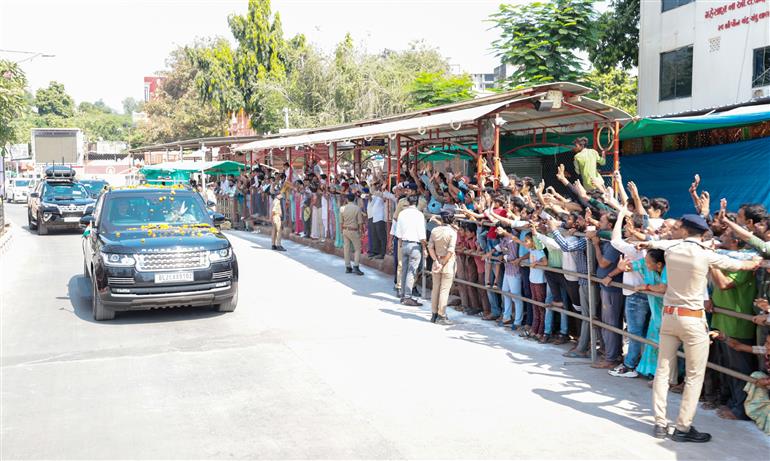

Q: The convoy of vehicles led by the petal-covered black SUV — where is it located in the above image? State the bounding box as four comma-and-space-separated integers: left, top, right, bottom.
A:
9, 165, 238, 321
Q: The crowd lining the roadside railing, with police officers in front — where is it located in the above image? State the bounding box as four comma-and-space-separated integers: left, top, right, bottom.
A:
205, 138, 770, 436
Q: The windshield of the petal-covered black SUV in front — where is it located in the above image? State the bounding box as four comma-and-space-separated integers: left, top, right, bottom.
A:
100, 191, 212, 232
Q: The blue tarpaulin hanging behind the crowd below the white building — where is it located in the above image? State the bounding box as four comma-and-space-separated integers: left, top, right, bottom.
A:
620, 138, 770, 218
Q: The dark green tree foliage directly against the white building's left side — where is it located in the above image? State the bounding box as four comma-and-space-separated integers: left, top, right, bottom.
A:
589, 0, 640, 71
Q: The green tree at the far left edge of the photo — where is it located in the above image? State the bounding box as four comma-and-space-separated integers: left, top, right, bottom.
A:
0, 60, 29, 150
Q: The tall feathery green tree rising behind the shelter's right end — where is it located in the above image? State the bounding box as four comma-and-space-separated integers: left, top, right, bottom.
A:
490, 0, 597, 87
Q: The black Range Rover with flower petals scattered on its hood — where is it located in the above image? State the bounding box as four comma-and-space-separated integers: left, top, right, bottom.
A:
81, 186, 238, 320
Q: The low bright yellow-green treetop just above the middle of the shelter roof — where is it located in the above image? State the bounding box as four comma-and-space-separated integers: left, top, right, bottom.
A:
410, 72, 473, 109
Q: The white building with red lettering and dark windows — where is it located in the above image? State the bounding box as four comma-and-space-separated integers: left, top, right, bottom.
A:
639, 0, 770, 116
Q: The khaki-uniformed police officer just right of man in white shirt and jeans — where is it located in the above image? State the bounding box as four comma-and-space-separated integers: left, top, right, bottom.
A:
428, 211, 457, 325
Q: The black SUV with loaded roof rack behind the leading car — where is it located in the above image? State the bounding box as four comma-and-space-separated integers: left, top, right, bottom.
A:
27, 165, 96, 235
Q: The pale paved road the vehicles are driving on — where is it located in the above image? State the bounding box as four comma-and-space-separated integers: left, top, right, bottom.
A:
0, 205, 770, 459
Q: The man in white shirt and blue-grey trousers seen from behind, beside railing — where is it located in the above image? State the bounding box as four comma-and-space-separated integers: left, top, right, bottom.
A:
396, 195, 427, 306
